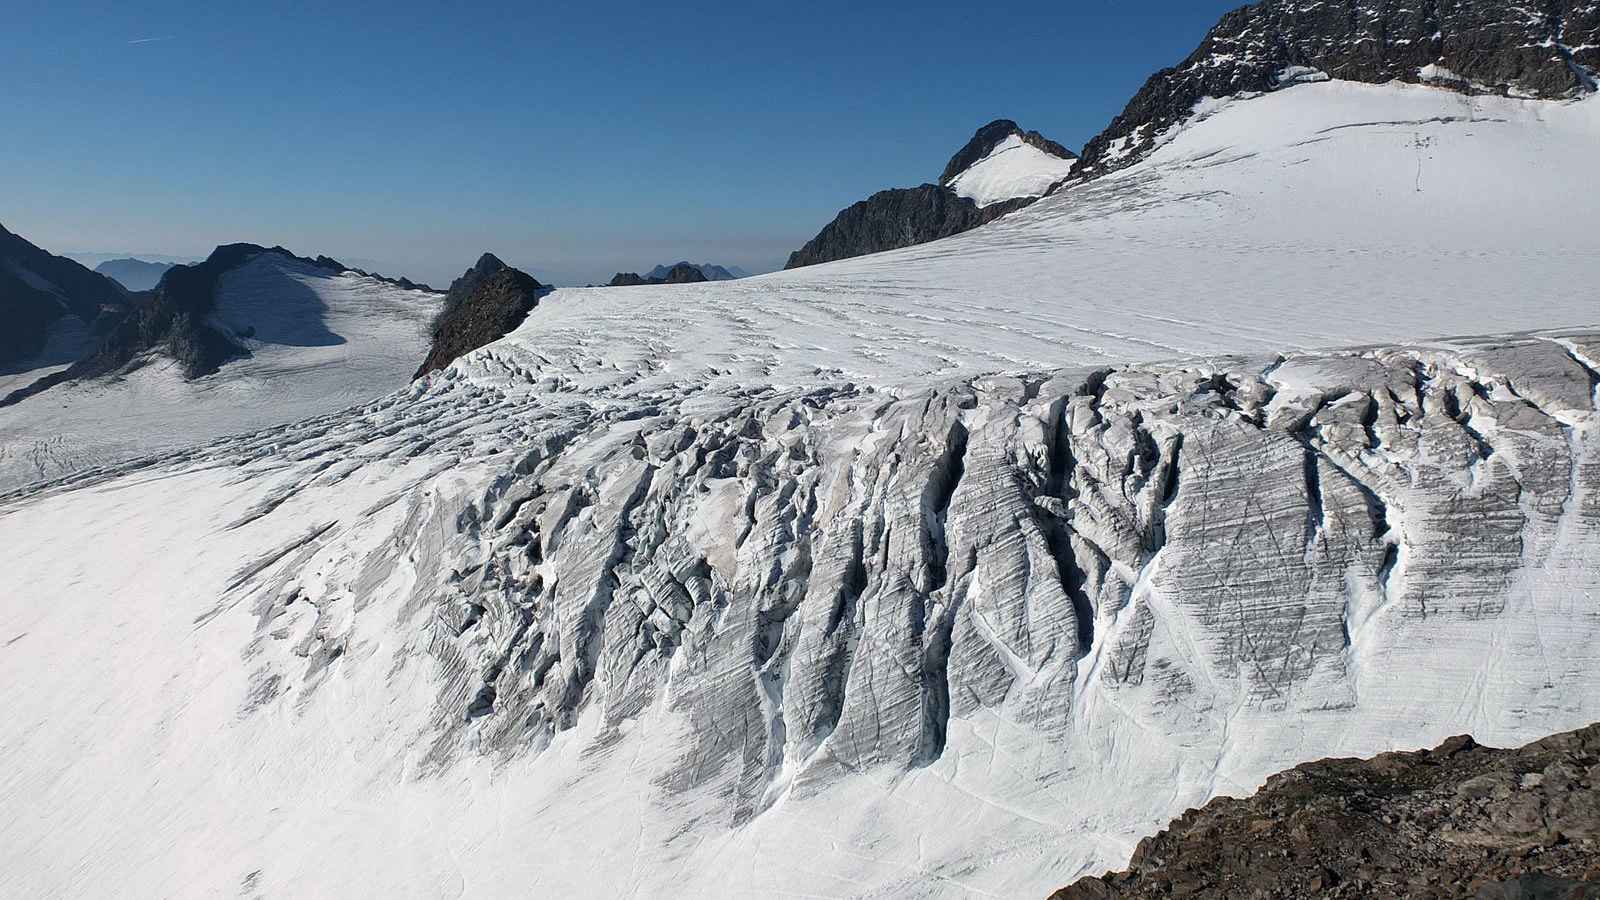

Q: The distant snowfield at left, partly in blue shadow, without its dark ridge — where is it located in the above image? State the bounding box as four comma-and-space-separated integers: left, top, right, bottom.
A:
0, 253, 440, 490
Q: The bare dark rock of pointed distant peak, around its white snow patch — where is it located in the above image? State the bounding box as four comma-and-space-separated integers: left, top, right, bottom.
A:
784, 119, 1074, 269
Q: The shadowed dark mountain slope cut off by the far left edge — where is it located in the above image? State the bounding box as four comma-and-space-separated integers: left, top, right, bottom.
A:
0, 226, 130, 370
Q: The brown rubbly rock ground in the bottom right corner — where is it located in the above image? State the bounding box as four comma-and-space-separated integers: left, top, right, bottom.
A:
1051, 725, 1600, 900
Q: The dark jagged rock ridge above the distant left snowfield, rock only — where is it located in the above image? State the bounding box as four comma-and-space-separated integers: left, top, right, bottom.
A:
0, 243, 429, 407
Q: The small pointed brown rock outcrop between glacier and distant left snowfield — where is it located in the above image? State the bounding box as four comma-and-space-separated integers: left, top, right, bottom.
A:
413, 253, 546, 378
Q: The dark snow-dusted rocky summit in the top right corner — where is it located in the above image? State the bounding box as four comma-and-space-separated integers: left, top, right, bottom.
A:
1078, 0, 1600, 178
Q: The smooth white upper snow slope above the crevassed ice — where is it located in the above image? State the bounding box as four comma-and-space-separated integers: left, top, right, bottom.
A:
525, 82, 1600, 386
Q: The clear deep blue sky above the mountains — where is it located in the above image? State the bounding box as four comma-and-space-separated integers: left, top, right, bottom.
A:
0, 0, 1238, 283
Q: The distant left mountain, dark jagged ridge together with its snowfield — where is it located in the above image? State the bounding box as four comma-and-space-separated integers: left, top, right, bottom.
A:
0, 239, 440, 490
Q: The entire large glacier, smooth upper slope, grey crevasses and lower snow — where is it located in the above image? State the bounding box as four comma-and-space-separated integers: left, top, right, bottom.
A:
0, 82, 1600, 897
